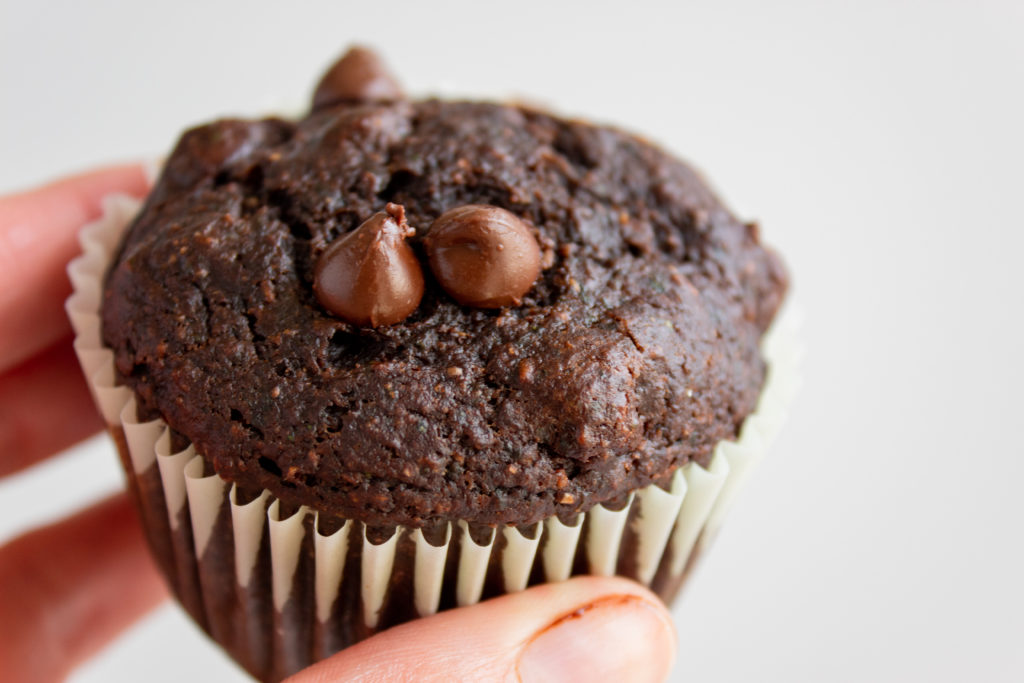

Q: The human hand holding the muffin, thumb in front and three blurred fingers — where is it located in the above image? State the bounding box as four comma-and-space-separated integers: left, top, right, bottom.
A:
0, 166, 676, 683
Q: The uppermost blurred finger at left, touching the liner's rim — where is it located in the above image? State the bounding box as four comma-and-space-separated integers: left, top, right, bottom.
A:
0, 164, 146, 372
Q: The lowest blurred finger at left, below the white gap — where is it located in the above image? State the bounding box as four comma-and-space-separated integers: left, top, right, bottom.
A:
0, 494, 166, 682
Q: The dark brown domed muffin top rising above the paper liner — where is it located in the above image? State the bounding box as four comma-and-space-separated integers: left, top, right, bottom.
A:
102, 50, 786, 526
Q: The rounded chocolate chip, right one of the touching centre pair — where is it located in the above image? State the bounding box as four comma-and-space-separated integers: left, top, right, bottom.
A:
424, 204, 541, 308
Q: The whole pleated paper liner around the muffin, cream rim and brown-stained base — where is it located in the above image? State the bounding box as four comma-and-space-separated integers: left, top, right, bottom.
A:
67, 196, 800, 680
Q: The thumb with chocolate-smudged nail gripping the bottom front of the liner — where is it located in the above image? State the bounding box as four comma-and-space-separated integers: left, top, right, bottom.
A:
289, 577, 676, 683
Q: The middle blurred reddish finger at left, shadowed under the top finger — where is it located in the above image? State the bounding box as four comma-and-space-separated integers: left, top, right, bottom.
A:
0, 339, 103, 477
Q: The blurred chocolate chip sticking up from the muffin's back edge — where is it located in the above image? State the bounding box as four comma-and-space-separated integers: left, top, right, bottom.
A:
313, 46, 402, 110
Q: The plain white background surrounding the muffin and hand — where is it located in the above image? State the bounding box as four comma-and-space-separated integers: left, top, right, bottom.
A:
0, 0, 1024, 682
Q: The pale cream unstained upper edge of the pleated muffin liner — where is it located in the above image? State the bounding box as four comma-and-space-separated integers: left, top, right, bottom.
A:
67, 196, 800, 679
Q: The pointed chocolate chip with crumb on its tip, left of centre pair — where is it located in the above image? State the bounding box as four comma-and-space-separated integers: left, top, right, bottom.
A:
313, 204, 423, 328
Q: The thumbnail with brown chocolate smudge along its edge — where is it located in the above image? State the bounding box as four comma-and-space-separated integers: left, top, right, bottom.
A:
517, 596, 676, 683
